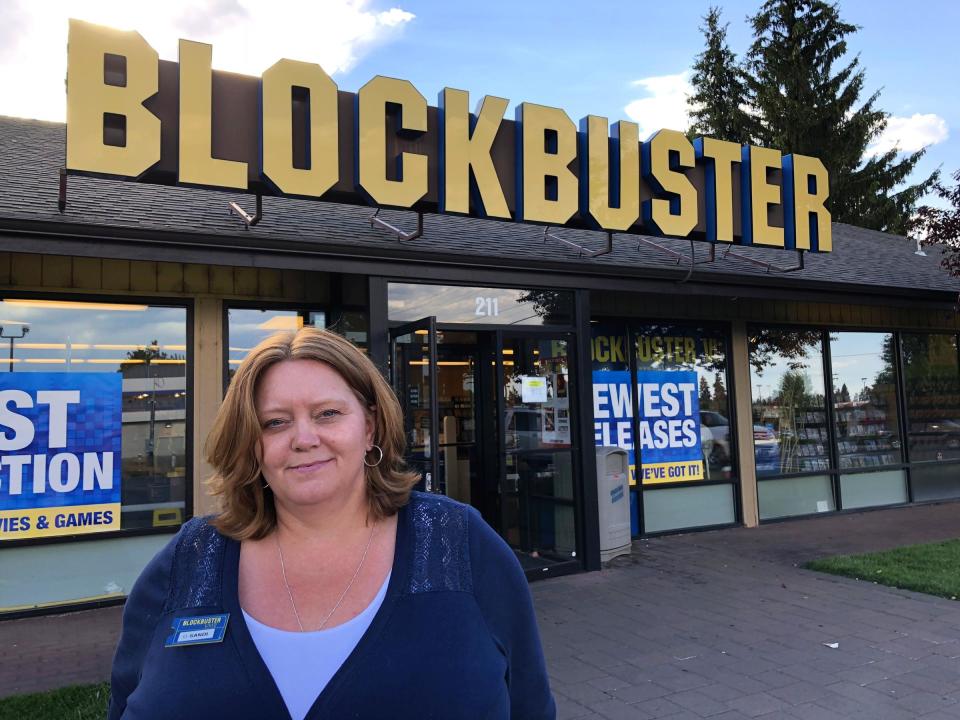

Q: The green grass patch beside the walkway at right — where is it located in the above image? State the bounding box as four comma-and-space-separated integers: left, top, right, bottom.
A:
804, 539, 960, 600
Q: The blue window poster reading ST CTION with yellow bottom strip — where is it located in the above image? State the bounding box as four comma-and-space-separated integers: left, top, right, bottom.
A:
0, 373, 122, 540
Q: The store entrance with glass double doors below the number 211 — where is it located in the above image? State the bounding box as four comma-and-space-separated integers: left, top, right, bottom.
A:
390, 317, 577, 574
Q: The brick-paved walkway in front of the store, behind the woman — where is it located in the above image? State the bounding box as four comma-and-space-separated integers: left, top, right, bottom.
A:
0, 503, 960, 720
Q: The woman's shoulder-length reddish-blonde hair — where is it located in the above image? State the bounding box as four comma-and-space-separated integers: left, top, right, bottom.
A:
204, 327, 420, 540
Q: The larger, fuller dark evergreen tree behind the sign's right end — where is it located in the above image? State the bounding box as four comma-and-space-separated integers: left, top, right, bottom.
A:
695, 0, 938, 234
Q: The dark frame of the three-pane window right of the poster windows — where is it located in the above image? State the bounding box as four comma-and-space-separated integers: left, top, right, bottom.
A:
747, 322, 960, 525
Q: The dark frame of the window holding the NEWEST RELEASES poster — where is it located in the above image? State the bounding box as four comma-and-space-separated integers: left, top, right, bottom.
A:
590, 315, 743, 537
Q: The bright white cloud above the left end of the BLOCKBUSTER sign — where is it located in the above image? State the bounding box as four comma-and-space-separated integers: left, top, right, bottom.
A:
0, 0, 415, 121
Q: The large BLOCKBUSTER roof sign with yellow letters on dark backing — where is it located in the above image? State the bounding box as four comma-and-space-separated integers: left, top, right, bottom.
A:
66, 20, 831, 252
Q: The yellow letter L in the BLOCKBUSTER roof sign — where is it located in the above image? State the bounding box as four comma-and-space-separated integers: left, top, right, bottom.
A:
177, 40, 247, 190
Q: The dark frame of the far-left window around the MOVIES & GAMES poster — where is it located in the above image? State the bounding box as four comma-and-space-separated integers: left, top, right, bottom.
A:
0, 290, 194, 548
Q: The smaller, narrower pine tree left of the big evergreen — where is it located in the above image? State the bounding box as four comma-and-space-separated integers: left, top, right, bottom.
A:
687, 7, 754, 143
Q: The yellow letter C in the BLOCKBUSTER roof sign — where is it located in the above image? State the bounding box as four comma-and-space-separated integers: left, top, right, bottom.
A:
356, 75, 428, 207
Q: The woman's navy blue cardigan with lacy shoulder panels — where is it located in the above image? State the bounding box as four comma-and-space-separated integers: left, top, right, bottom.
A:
108, 493, 556, 720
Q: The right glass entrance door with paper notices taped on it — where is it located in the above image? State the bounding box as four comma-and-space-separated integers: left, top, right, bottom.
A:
495, 331, 577, 571
